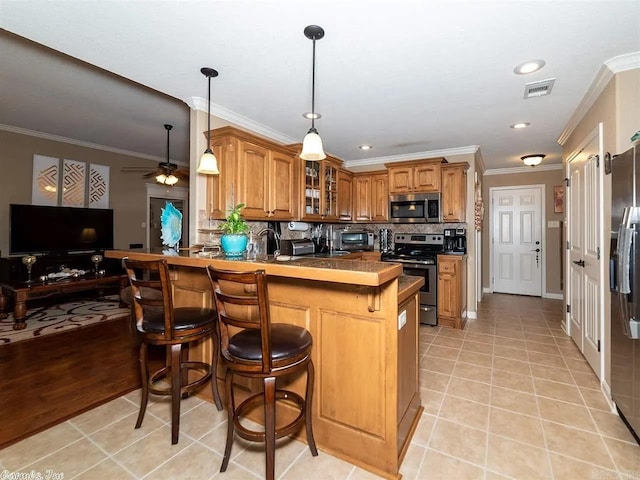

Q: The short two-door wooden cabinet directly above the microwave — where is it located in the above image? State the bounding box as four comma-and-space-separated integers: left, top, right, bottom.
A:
386, 157, 446, 195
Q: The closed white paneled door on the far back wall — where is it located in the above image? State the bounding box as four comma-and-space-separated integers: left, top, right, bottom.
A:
491, 186, 543, 296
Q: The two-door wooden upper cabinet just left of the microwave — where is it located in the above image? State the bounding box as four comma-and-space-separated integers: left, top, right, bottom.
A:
353, 172, 389, 222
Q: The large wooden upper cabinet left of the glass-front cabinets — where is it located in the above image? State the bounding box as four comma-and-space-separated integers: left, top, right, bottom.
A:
207, 127, 298, 220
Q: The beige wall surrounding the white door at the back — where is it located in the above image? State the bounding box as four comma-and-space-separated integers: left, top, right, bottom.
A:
482, 167, 564, 295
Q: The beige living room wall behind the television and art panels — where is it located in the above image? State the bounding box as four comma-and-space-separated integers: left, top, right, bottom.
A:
0, 130, 168, 256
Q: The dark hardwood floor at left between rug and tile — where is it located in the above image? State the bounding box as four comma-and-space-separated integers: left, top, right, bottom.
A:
0, 317, 146, 449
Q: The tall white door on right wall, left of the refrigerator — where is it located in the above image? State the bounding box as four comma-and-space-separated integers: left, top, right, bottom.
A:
568, 128, 604, 377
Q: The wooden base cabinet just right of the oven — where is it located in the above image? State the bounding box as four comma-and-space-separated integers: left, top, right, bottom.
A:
438, 255, 467, 329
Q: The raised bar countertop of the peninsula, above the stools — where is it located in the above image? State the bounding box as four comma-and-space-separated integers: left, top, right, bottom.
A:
105, 249, 402, 287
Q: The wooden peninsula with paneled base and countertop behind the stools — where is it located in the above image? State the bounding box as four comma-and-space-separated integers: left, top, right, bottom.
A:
106, 251, 424, 478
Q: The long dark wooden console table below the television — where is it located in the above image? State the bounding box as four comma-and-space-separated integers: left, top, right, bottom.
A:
0, 273, 127, 330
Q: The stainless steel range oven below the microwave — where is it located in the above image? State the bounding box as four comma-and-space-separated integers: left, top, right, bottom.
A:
382, 233, 444, 326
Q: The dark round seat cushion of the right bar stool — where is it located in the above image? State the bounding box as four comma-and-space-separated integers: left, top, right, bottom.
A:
229, 323, 313, 362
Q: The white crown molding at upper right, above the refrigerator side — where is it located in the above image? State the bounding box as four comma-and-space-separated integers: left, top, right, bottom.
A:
557, 52, 640, 145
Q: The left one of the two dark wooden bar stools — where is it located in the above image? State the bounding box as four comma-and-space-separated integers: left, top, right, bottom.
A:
123, 259, 222, 444
